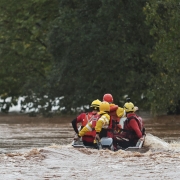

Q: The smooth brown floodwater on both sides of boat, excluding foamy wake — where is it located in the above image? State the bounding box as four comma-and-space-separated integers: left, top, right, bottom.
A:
0, 114, 180, 152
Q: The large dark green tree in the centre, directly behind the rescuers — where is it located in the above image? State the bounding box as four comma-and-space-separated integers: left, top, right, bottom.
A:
49, 0, 155, 109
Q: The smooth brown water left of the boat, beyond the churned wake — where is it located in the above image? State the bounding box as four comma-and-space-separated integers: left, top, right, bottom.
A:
0, 114, 74, 152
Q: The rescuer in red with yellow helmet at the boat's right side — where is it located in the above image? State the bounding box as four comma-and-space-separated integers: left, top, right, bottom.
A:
113, 102, 145, 149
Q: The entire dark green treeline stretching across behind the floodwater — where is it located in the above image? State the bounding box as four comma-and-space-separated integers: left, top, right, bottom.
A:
0, 0, 180, 115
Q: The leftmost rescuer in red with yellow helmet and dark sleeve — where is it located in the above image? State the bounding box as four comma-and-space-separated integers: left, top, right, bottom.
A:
72, 99, 101, 146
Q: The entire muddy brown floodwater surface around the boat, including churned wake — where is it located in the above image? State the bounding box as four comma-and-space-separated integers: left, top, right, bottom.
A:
0, 112, 180, 180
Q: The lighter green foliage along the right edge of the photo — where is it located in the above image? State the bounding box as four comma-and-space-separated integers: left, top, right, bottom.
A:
144, 0, 180, 112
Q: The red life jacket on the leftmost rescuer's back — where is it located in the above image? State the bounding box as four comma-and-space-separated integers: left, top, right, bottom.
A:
82, 113, 99, 137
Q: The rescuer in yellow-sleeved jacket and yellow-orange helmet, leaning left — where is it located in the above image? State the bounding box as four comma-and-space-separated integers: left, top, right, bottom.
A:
79, 102, 110, 140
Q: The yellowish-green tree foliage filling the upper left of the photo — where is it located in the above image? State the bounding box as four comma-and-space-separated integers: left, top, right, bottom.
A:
0, 0, 59, 112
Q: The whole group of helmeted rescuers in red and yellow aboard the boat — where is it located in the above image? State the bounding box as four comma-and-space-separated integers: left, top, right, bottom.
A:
72, 94, 145, 150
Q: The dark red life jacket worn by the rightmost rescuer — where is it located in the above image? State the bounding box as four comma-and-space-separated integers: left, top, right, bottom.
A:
123, 115, 145, 140
